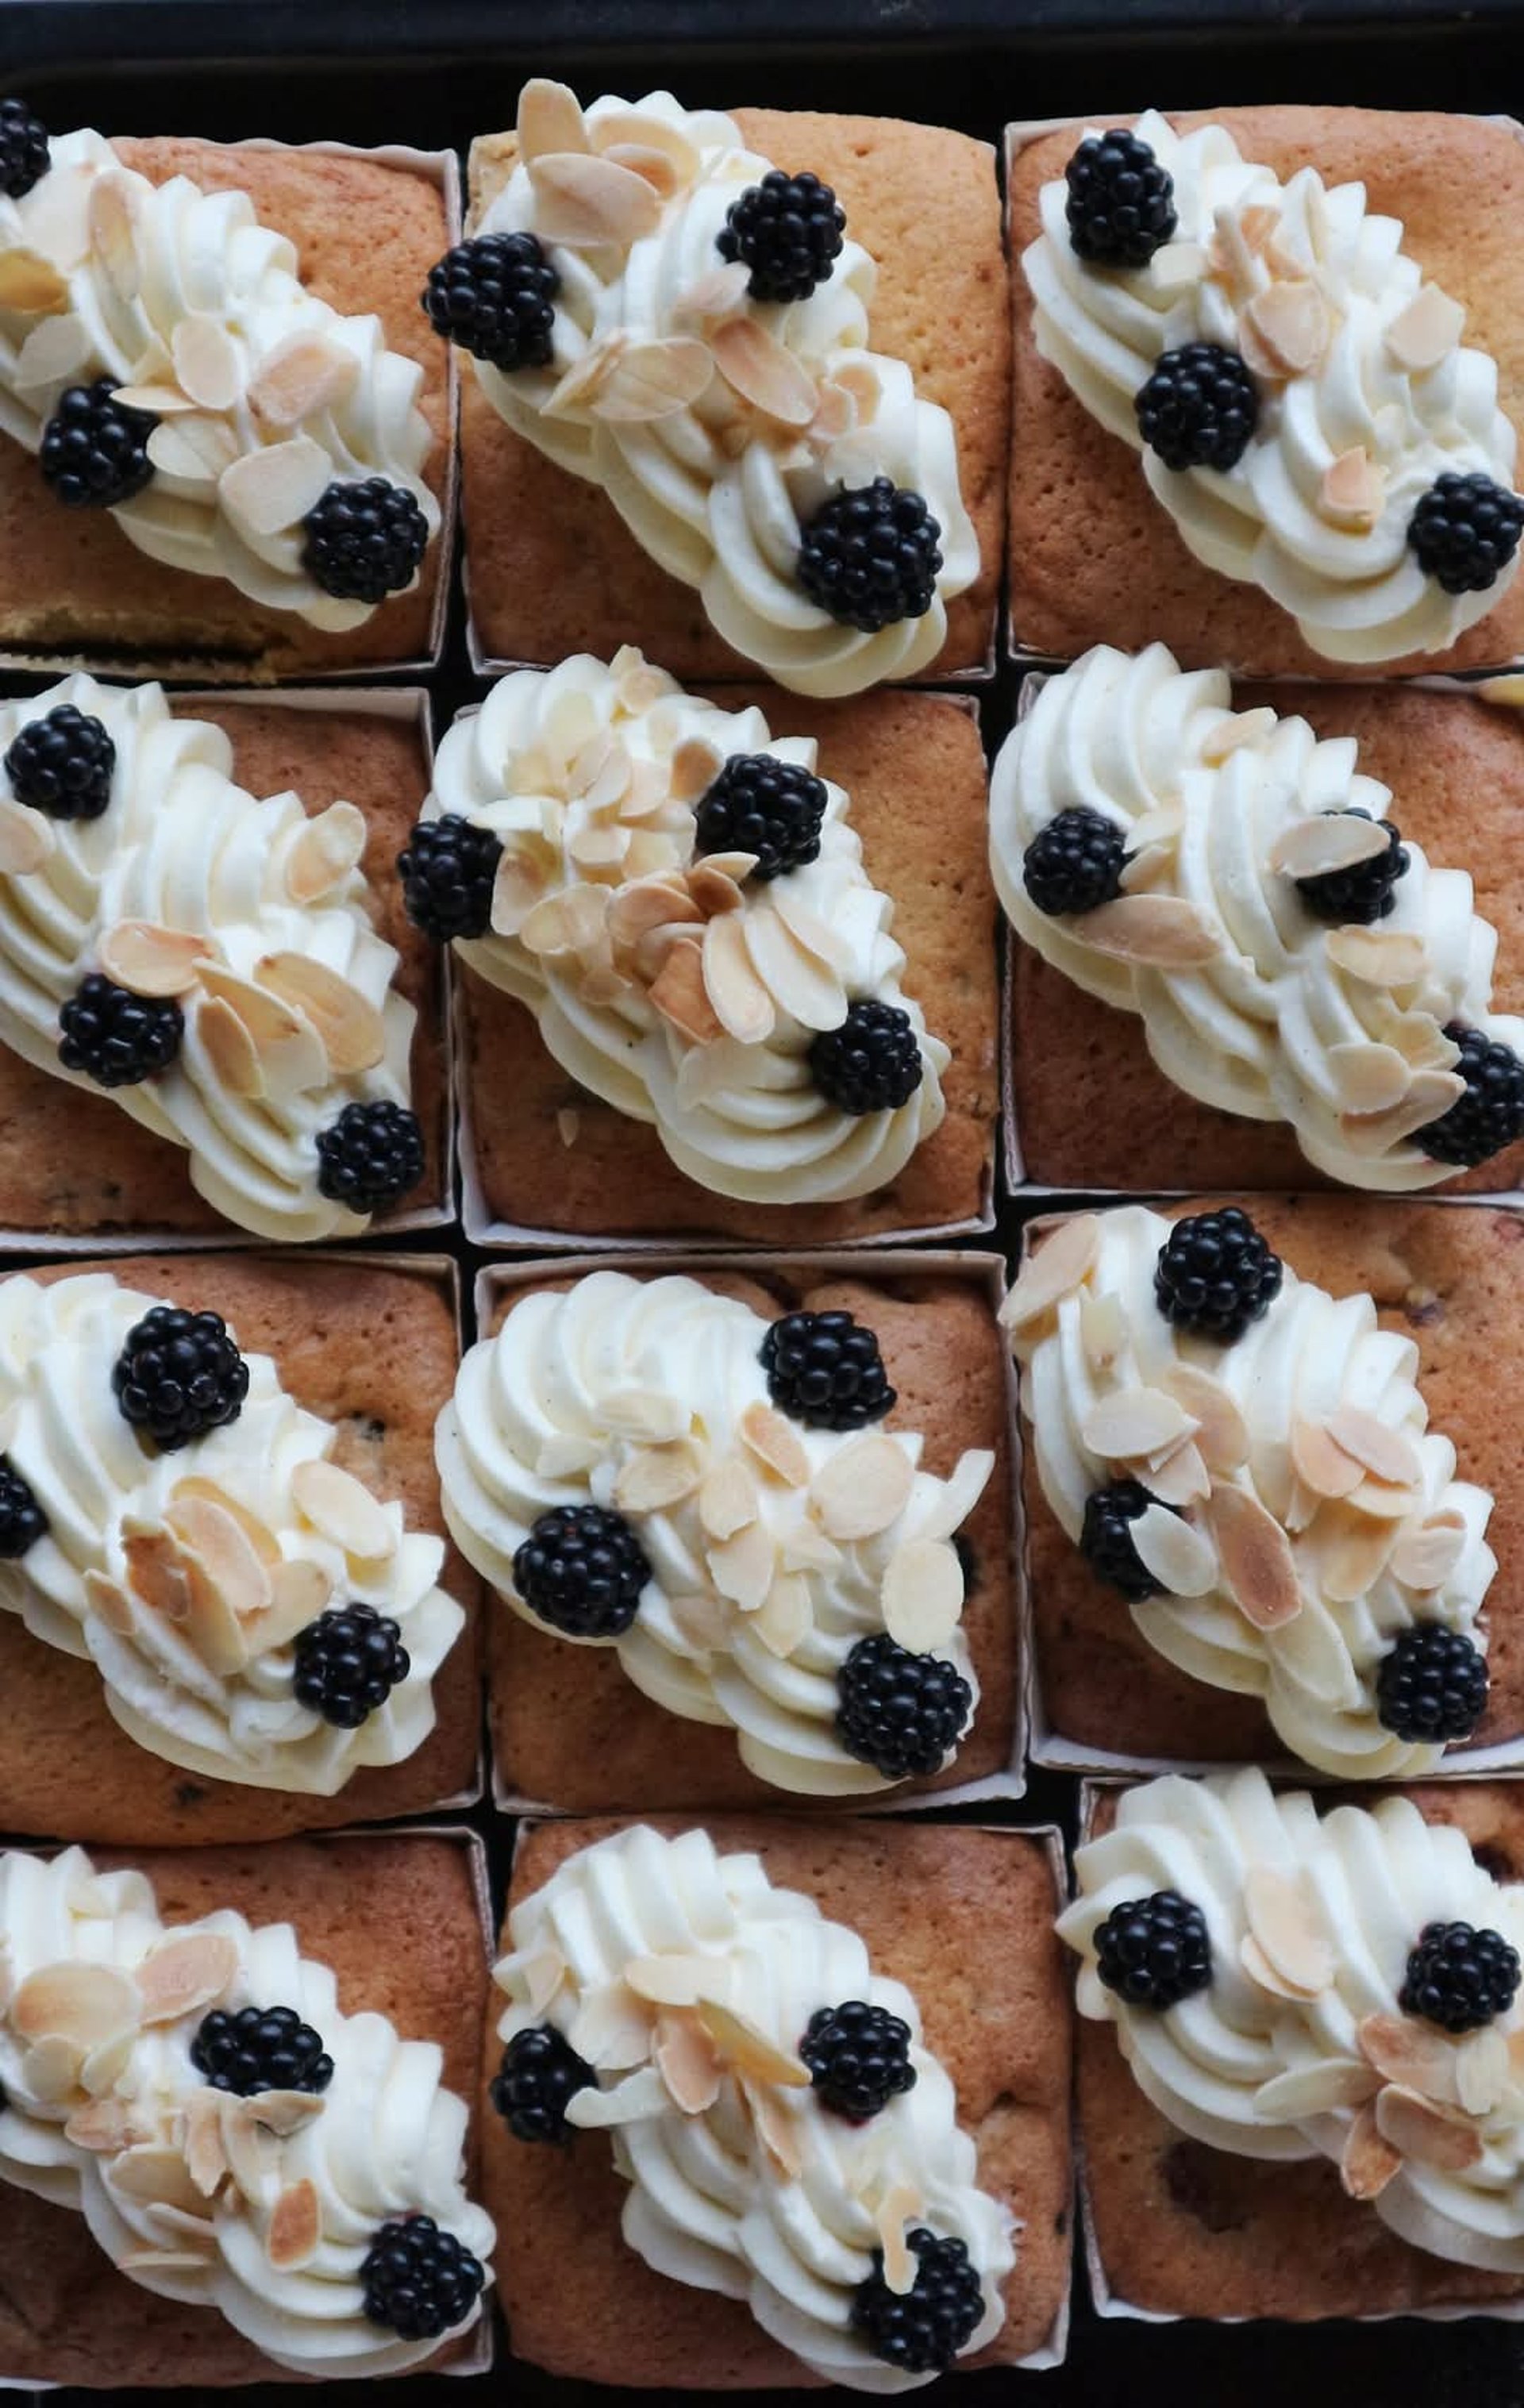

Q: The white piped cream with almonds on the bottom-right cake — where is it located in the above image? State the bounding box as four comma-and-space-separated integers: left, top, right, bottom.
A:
1060, 1768, 1524, 2275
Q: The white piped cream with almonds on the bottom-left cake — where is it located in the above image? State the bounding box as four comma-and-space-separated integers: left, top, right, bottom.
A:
0, 1847, 494, 2377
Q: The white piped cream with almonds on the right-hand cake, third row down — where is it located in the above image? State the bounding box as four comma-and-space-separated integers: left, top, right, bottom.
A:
1004, 1204, 1498, 1779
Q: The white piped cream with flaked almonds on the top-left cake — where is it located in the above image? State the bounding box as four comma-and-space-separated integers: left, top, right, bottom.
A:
0, 133, 441, 633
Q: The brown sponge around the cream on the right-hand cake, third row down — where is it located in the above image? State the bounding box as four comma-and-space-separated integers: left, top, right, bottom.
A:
1021, 1197, 1524, 1770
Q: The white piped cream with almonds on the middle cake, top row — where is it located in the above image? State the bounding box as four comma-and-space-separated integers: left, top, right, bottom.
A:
475, 79, 980, 694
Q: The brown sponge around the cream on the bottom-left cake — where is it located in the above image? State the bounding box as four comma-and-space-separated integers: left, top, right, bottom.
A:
0, 1837, 487, 2391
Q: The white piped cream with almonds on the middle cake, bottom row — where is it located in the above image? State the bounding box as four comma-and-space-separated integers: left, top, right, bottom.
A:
494, 1825, 1016, 2391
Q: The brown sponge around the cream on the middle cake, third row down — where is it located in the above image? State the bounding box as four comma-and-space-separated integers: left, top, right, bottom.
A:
484, 1264, 1016, 1814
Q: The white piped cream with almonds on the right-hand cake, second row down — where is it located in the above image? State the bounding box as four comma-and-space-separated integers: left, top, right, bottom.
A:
990, 643, 1524, 1192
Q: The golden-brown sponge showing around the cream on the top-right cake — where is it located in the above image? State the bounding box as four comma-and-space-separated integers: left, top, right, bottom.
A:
1009, 109, 1524, 679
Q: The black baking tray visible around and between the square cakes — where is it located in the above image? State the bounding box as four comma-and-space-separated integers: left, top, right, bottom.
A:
0, 0, 1524, 2408
